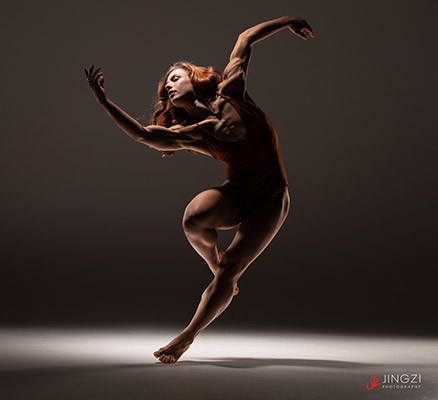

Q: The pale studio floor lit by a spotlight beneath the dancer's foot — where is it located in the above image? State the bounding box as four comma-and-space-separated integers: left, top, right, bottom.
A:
0, 327, 438, 400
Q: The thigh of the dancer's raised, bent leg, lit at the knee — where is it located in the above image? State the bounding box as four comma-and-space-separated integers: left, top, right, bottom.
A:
184, 184, 243, 229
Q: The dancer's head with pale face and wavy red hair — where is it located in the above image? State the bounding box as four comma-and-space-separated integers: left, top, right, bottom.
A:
152, 62, 222, 126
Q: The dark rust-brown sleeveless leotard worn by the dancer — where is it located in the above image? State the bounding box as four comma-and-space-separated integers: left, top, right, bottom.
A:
199, 92, 288, 215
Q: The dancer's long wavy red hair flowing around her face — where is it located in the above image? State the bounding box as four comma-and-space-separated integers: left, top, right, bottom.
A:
152, 61, 223, 127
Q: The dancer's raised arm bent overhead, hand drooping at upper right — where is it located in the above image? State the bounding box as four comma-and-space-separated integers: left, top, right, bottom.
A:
219, 16, 314, 96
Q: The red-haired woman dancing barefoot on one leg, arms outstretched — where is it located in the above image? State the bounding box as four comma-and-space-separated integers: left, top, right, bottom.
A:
85, 17, 314, 363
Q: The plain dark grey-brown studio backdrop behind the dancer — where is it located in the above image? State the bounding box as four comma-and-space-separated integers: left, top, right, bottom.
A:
0, 0, 438, 335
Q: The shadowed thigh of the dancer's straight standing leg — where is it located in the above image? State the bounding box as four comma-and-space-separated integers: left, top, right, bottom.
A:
224, 188, 290, 276
